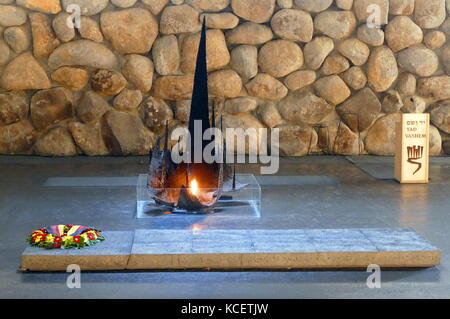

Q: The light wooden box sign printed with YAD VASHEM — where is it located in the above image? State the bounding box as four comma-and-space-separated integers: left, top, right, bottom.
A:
395, 113, 430, 184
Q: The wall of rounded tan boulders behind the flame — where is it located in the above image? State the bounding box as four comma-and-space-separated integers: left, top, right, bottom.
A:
0, 0, 450, 156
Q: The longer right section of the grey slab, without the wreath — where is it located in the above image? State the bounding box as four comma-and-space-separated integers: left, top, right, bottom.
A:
128, 229, 440, 269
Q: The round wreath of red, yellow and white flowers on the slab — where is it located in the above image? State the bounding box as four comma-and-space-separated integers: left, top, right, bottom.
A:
27, 225, 105, 249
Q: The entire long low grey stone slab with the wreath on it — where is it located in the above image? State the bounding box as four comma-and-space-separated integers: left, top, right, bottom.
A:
20, 229, 440, 271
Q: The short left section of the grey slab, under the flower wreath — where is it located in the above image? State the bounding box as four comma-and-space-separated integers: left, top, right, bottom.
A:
20, 231, 134, 271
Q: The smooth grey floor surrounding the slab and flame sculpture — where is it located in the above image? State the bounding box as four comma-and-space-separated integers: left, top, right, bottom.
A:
0, 156, 450, 298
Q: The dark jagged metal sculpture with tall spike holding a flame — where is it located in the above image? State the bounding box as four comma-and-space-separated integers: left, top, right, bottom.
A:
148, 21, 230, 213
